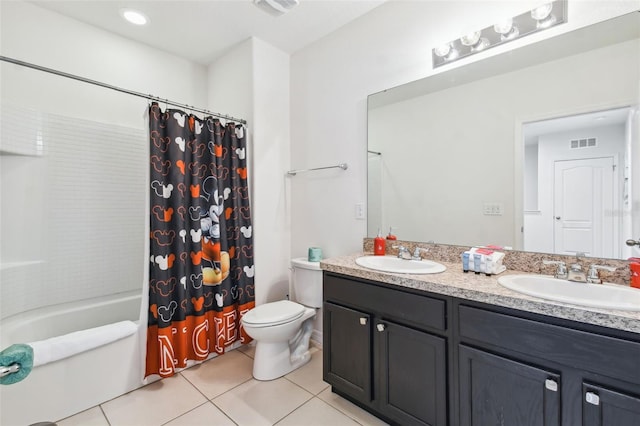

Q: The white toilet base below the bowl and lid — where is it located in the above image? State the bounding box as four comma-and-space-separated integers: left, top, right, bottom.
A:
253, 318, 313, 381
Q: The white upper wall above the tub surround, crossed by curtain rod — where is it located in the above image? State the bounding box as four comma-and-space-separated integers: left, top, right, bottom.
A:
0, 1, 206, 127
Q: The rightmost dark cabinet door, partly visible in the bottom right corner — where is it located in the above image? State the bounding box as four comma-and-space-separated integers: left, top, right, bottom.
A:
582, 383, 640, 426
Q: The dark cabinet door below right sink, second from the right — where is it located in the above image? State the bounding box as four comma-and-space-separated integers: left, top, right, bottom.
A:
459, 345, 560, 426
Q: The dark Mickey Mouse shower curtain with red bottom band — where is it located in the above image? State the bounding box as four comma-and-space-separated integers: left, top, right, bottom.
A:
145, 103, 254, 377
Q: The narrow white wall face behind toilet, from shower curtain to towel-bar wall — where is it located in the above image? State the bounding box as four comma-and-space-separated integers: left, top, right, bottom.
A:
251, 39, 291, 304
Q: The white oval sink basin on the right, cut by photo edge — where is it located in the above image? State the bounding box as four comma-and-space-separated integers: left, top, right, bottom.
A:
498, 275, 640, 311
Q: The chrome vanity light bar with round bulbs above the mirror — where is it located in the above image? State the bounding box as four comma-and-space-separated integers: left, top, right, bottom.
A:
431, 0, 567, 68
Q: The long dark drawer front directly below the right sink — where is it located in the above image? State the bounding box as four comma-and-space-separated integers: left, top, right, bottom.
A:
459, 305, 640, 384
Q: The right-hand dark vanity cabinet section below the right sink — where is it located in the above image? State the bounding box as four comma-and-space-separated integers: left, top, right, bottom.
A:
456, 302, 640, 426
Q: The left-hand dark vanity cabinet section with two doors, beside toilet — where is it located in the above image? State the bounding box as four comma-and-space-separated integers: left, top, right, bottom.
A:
323, 276, 448, 426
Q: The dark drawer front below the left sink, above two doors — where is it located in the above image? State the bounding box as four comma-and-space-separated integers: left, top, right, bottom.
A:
324, 273, 447, 330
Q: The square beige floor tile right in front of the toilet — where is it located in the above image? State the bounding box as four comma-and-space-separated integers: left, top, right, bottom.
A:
213, 378, 312, 426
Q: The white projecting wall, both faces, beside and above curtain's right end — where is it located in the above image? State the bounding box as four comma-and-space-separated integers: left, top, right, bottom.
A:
208, 38, 290, 304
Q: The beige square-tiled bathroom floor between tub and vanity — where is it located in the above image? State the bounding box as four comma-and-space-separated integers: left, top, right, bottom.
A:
57, 345, 386, 426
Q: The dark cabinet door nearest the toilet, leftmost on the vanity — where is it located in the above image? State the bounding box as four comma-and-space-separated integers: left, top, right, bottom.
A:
323, 303, 372, 403
